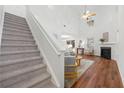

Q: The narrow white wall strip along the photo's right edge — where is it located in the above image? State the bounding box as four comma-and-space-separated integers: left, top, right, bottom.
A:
117, 6, 124, 83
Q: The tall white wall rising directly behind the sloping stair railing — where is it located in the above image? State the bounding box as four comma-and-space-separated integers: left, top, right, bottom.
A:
30, 5, 79, 47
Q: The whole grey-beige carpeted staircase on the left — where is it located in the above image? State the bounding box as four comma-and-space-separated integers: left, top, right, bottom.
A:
0, 13, 56, 88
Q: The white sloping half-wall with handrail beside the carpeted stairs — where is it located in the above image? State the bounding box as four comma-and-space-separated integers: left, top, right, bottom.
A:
26, 7, 64, 87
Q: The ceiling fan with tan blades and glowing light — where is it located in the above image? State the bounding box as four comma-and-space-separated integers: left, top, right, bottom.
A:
81, 6, 96, 26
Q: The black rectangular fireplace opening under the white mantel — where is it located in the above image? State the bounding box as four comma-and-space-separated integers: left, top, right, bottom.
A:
101, 47, 111, 59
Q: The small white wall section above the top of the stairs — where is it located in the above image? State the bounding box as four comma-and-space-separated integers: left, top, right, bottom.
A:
4, 5, 26, 17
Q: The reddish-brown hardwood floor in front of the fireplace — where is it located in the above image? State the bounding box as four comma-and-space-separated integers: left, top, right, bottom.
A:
72, 56, 123, 88
